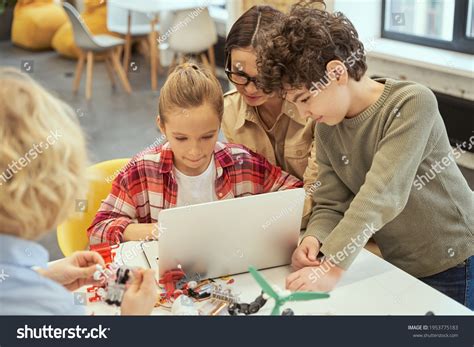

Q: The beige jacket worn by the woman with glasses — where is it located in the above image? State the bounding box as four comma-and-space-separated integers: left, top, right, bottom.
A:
222, 90, 318, 228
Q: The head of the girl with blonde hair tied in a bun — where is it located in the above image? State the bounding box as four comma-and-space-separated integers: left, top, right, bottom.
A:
157, 63, 224, 176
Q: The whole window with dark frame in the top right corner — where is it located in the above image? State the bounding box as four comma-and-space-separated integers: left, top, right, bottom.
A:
382, 0, 474, 54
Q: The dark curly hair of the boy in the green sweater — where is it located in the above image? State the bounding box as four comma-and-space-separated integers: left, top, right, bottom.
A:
257, 0, 367, 93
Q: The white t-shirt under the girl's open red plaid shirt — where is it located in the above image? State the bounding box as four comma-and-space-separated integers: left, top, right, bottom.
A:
174, 157, 218, 206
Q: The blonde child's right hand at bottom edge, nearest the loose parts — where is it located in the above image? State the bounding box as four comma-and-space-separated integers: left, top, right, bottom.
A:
121, 269, 158, 316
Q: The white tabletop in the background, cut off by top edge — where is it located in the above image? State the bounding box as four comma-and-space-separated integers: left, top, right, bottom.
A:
109, 0, 226, 13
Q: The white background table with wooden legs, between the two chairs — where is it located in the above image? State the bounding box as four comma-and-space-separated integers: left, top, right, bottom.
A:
109, 0, 226, 90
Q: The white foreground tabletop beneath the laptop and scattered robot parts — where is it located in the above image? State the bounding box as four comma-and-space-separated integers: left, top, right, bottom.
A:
73, 242, 474, 315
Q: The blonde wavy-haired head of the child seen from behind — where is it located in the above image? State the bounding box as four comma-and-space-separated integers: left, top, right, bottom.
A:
0, 68, 87, 239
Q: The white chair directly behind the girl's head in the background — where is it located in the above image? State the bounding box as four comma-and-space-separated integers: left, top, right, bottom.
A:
168, 8, 218, 73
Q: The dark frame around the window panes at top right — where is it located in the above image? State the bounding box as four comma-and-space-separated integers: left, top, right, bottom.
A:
381, 0, 474, 54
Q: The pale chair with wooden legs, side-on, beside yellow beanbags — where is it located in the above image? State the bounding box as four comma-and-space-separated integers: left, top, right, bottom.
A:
63, 2, 132, 99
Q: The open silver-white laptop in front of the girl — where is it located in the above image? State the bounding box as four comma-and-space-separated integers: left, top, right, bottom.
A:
142, 188, 305, 279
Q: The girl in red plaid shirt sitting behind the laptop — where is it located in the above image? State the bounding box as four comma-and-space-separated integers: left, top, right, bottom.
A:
88, 63, 303, 244
